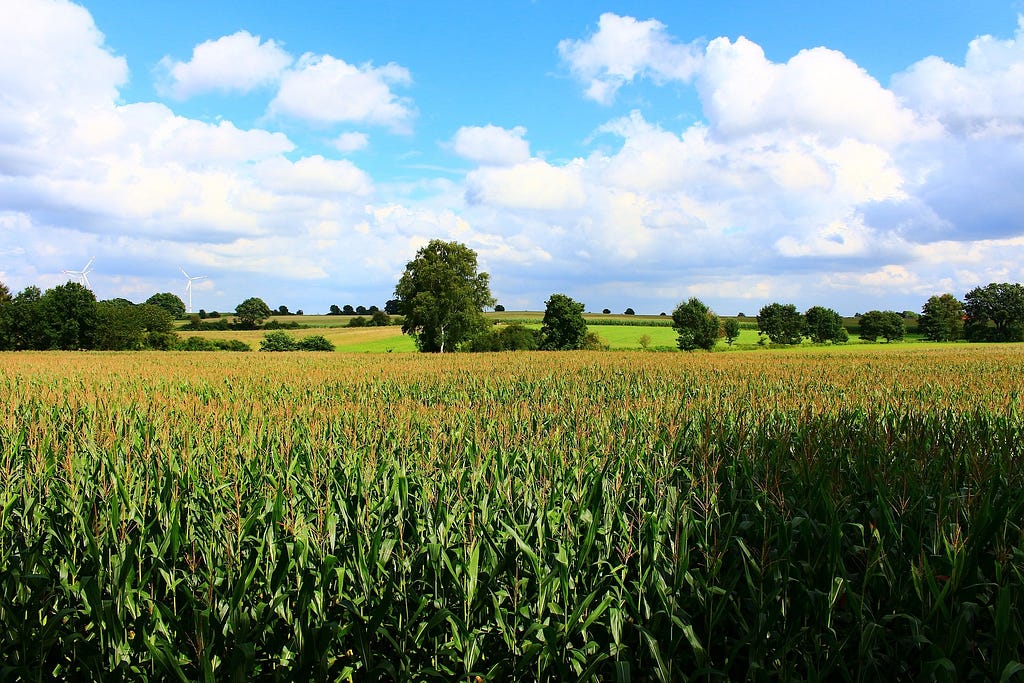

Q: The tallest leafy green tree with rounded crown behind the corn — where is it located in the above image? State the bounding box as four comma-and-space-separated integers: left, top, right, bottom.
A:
394, 240, 495, 353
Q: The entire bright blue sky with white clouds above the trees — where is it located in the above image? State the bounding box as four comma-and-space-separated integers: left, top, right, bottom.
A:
0, 0, 1024, 314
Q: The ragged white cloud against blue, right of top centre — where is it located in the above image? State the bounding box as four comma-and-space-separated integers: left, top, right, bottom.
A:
558, 12, 700, 104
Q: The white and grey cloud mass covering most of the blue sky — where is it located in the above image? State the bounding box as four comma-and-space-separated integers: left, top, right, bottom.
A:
0, 0, 1024, 313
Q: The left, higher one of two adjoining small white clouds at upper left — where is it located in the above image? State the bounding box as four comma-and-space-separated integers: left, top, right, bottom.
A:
160, 31, 293, 99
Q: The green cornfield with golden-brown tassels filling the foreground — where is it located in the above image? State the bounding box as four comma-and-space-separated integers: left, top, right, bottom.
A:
0, 345, 1024, 681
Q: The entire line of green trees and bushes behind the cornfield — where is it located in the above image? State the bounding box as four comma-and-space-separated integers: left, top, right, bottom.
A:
0, 240, 1024, 352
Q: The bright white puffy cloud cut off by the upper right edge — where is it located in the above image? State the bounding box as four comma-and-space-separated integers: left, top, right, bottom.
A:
892, 16, 1024, 134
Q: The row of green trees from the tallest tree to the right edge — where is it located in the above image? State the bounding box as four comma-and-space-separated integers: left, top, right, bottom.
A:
389, 240, 1024, 352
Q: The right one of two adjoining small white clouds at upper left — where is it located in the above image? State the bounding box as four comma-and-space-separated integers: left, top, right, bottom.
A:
270, 53, 414, 131
